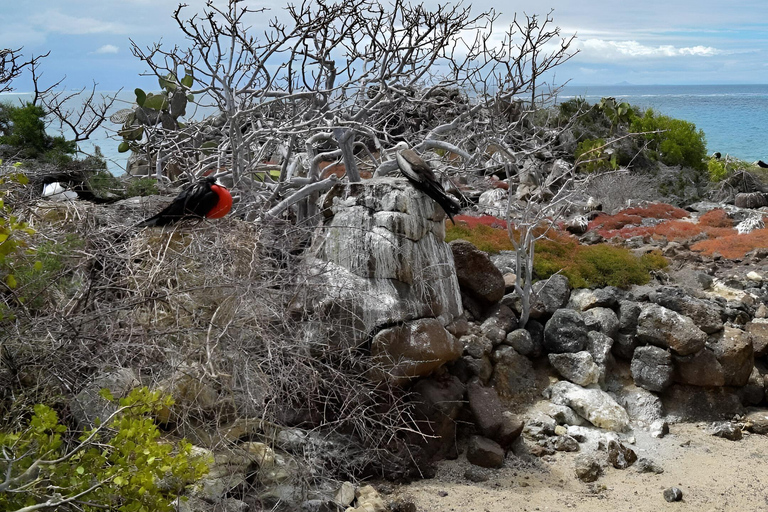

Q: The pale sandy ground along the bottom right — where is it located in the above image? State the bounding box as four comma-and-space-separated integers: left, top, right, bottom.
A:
389, 424, 768, 512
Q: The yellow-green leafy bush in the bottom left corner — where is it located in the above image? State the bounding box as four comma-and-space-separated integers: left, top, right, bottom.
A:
0, 388, 210, 512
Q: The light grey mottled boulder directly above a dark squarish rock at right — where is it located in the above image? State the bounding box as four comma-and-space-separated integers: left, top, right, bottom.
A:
637, 304, 707, 356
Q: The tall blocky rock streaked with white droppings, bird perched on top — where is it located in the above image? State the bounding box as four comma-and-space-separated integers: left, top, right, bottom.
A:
306, 178, 462, 346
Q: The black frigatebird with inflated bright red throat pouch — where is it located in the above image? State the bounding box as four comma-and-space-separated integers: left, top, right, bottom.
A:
136, 176, 232, 228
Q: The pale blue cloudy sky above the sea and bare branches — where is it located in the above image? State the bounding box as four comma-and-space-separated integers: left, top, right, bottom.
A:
0, 0, 768, 90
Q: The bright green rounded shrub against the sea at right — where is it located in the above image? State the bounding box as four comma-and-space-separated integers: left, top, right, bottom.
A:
631, 108, 707, 171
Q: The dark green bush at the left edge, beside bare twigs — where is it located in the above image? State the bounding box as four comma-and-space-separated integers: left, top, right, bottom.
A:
0, 103, 77, 163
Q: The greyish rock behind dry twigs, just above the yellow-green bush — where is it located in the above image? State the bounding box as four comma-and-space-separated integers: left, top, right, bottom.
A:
69, 368, 141, 428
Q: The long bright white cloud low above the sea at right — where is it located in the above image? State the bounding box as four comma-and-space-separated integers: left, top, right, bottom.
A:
577, 39, 725, 60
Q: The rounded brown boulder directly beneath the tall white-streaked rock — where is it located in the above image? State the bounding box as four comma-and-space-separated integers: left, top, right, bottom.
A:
371, 318, 462, 385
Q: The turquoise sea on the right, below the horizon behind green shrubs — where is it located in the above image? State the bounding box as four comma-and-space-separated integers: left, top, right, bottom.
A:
559, 85, 768, 162
